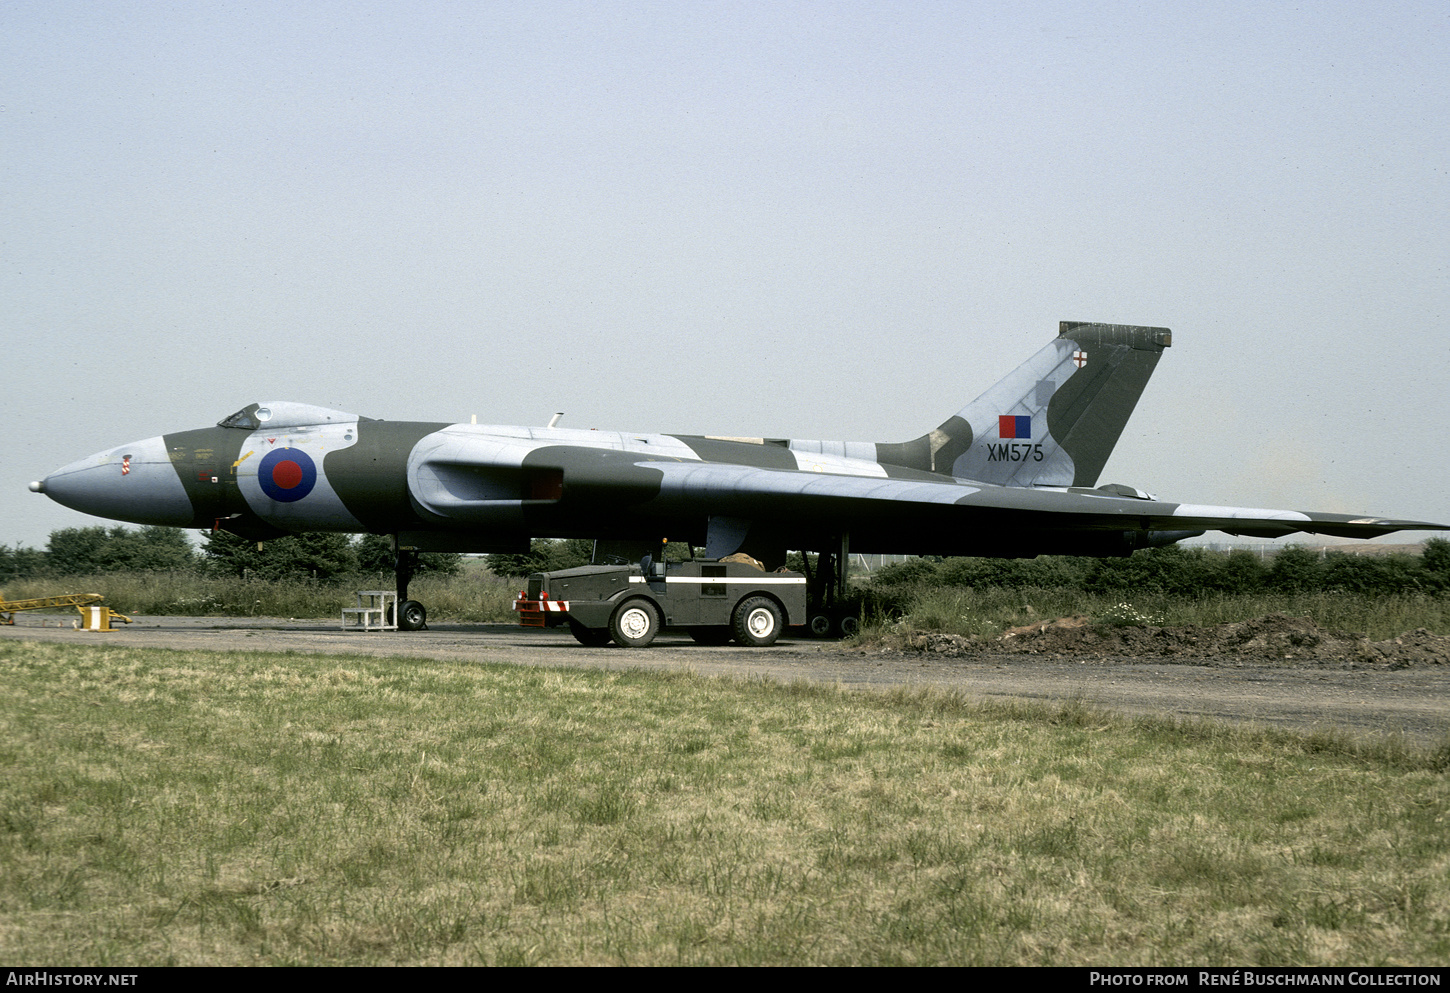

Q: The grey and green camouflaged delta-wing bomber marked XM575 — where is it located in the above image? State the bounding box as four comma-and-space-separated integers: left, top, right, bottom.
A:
30, 322, 1450, 628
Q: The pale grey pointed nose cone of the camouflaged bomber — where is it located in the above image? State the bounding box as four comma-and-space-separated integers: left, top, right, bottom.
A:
30, 438, 196, 528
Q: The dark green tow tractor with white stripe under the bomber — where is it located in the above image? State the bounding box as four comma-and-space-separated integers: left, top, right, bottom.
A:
513, 555, 806, 648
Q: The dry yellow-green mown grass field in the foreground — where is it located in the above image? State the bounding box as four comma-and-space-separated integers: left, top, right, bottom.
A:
0, 641, 1450, 965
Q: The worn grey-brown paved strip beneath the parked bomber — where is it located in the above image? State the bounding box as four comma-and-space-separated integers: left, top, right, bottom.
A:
0, 615, 1450, 744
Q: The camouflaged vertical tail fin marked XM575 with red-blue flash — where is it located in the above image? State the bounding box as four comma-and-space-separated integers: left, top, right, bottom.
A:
876, 320, 1173, 486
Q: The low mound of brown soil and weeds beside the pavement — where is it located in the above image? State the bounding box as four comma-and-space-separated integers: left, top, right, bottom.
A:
902, 613, 1450, 668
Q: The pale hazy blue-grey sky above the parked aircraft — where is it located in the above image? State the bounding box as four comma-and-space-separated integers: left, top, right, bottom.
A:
0, 0, 1450, 545
